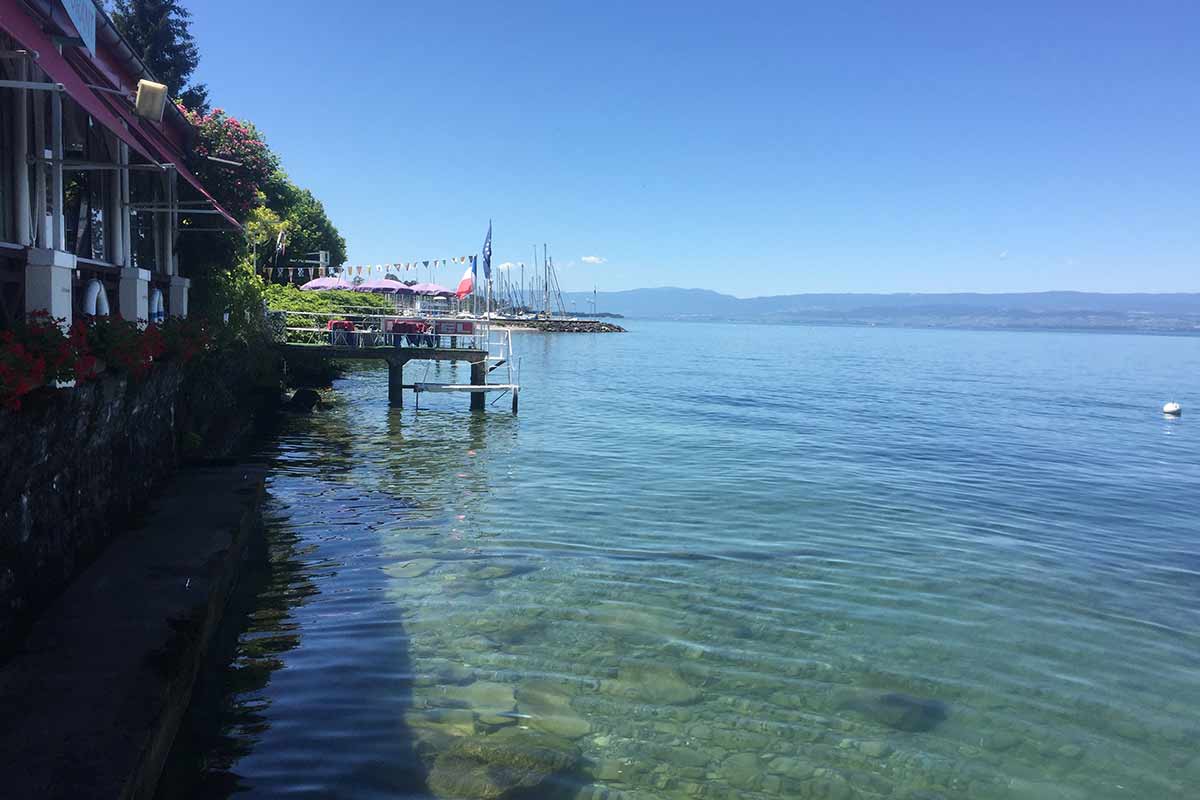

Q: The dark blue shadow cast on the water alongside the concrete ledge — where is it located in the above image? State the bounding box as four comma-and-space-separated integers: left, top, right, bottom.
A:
157, 395, 506, 800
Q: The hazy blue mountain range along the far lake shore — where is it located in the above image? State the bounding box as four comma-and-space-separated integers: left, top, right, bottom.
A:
563, 288, 1200, 333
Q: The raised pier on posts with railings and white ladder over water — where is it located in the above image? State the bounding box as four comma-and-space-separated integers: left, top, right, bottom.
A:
272, 312, 521, 414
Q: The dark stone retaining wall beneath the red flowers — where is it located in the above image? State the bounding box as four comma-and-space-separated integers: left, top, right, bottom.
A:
0, 351, 278, 658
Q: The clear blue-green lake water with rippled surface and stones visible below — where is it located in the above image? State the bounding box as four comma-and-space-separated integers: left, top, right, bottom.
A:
163, 324, 1200, 800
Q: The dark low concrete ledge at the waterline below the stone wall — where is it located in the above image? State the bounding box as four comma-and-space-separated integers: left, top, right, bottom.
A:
0, 464, 263, 799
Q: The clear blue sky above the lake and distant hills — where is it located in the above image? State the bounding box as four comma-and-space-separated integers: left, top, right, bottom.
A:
185, 0, 1200, 296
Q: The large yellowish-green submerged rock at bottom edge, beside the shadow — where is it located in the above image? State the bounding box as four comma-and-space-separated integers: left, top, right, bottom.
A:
427, 728, 580, 800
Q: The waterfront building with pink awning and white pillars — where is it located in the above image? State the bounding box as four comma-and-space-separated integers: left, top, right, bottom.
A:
0, 0, 238, 327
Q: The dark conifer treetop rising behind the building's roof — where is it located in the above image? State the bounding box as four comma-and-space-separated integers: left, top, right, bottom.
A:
112, 0, 209, 110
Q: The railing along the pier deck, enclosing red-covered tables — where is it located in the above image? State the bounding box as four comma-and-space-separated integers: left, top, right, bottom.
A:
266, 308, 491, 350
